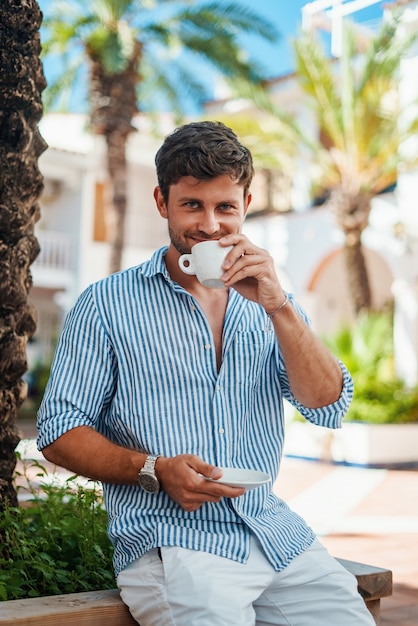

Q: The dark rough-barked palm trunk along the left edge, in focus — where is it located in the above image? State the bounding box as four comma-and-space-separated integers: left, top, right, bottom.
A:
0, 0, 45, 512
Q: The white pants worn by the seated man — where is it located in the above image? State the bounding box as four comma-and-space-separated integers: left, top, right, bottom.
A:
117, 537, 375, 626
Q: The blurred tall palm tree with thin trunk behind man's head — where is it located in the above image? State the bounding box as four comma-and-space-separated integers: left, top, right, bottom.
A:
44, 0, 276, 272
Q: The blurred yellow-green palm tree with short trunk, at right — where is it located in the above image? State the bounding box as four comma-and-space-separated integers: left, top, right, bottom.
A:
295, 16, 418, 314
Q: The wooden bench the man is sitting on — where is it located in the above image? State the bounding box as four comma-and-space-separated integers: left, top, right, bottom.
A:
0, 559, 392, 626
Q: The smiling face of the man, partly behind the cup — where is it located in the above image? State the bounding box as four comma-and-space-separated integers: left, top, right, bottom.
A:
154, 175, 251, 254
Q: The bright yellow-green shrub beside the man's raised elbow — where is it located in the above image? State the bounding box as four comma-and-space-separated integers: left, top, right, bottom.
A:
325, 313, 418, 424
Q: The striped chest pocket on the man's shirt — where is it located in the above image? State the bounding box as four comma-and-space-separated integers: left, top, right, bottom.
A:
233, 330, 274, 387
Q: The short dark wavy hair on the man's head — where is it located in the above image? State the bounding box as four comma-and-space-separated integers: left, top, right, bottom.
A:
155, 121, 254, 202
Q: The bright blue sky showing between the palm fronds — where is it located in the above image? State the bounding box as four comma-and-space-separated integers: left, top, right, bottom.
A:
38, 0, 387, 111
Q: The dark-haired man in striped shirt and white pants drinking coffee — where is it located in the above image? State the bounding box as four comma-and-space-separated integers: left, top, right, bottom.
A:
38, 122, 374, 626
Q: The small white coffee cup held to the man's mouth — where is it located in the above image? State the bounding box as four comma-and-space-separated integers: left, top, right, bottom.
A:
179, 241, 233, 289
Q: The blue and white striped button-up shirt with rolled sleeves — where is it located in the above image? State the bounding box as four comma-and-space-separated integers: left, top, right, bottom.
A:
38, 248, 353, 575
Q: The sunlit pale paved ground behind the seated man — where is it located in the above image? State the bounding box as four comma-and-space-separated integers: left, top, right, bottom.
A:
15, 424, 418, 626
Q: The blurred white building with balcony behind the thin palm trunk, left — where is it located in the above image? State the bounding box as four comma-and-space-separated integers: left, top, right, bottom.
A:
29, 114, 172, 363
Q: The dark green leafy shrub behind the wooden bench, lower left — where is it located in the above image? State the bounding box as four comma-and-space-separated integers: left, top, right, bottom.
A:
0, 461, 115, 600
